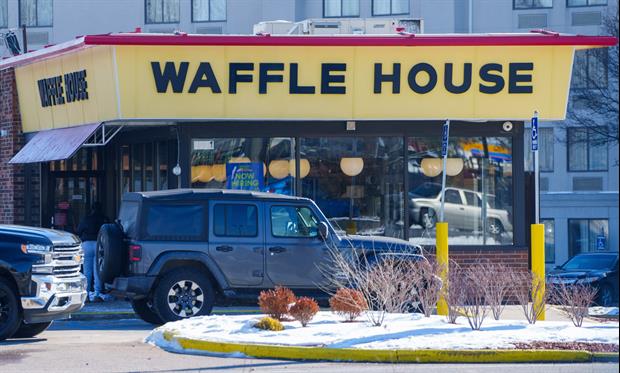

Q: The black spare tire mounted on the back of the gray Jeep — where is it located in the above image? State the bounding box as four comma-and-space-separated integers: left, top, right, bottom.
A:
97, 224, 126, 283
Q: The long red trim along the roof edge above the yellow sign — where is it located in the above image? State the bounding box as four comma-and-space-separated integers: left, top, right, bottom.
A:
84, 34, 618, 47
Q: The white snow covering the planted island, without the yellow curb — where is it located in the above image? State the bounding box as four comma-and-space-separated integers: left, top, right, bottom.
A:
145, 311, 618, 350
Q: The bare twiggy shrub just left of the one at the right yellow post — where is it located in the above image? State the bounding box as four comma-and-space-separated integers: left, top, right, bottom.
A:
485, 263, 515, 320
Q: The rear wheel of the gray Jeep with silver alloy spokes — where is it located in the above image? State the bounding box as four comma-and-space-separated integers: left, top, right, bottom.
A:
153, 268, 215, 322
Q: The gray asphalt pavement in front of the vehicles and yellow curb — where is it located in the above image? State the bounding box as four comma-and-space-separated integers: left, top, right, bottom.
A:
0, 319, 618, 373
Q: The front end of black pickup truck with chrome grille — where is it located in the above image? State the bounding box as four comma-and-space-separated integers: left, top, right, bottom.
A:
0, 225, 86, 341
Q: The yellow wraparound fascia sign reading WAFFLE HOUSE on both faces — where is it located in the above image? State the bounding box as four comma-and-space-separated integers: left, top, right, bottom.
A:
16, 45, 574, 131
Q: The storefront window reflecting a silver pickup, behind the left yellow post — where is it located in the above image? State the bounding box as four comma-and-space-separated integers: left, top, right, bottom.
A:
408, 137, 513, 245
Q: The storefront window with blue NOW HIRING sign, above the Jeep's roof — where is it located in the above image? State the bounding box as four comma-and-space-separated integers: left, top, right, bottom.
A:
191, 137, 296, 195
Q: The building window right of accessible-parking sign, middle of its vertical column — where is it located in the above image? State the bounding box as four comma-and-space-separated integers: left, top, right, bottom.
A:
567, 127, 607, 171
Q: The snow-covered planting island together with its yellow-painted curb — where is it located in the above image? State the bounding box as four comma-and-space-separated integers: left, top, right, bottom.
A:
145, 312, 618, 362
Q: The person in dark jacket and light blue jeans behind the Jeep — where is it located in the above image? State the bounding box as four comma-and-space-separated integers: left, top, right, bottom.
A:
77, 202, 107, 302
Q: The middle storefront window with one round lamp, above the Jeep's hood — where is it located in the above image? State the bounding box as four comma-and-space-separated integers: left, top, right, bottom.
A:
300, 137, 404, 237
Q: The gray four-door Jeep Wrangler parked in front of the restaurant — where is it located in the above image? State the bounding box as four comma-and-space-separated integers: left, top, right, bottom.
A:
97, 189, 424, 324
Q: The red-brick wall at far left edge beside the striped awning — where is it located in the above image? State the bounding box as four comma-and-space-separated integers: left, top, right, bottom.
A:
0, 69, 41, 226
